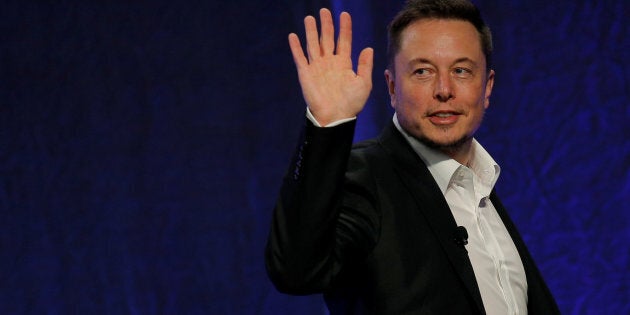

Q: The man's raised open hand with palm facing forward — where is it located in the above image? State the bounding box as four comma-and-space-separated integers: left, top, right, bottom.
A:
289, 9, 374, 126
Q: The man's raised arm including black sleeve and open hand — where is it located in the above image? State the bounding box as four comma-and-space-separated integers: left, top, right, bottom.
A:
266, 9, 372, 294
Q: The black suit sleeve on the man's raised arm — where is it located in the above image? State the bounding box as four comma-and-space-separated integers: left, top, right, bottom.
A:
265, 121, 380, 294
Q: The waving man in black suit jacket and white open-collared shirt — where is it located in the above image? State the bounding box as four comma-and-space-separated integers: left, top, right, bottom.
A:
266, 0, 559, 314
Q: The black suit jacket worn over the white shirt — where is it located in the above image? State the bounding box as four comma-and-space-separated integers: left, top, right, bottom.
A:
266, 122, 559, 314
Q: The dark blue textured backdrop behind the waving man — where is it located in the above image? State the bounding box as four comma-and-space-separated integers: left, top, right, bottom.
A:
0, 0, 630, 314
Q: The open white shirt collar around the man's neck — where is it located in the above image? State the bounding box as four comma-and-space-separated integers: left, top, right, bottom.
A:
392, 113, 501, 194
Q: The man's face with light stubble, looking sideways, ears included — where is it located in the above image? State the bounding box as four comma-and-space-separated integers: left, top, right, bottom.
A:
385, 19, 494, 150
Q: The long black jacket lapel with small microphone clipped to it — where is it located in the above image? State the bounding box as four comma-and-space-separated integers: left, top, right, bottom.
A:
379, 123, 484, 312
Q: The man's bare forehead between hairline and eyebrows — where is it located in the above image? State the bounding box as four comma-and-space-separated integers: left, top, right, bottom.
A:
396, 19, 485, 62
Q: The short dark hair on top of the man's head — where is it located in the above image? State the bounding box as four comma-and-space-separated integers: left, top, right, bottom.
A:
387, 0, 492, 71
